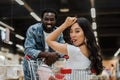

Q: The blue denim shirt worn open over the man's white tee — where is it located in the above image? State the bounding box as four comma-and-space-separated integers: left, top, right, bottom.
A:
23, 23, 64, 80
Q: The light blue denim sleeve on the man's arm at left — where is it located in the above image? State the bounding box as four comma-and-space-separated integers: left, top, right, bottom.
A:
24, 26, 41, 58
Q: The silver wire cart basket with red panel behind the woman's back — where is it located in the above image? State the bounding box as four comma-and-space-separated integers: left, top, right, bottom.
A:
56, 69, 92, 80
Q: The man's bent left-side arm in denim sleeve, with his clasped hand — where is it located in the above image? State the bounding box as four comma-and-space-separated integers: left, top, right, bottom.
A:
24, 25, 59, 64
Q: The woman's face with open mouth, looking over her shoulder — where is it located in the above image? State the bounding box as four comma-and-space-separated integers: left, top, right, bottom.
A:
70, 23, 85, 46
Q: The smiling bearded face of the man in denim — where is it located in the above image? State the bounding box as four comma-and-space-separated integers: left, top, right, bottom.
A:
42, 12, 56, 32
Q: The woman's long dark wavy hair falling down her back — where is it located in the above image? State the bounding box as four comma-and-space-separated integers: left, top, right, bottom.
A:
63, 17, 103, 75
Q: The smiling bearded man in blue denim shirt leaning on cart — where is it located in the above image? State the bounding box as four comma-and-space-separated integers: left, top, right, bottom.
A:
23, 9, 64, 80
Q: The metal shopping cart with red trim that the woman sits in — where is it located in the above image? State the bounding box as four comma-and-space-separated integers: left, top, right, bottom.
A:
28, 55, 92, 80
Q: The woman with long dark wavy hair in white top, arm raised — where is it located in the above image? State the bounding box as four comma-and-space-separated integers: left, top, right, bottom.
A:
46, 17, 103, 79
